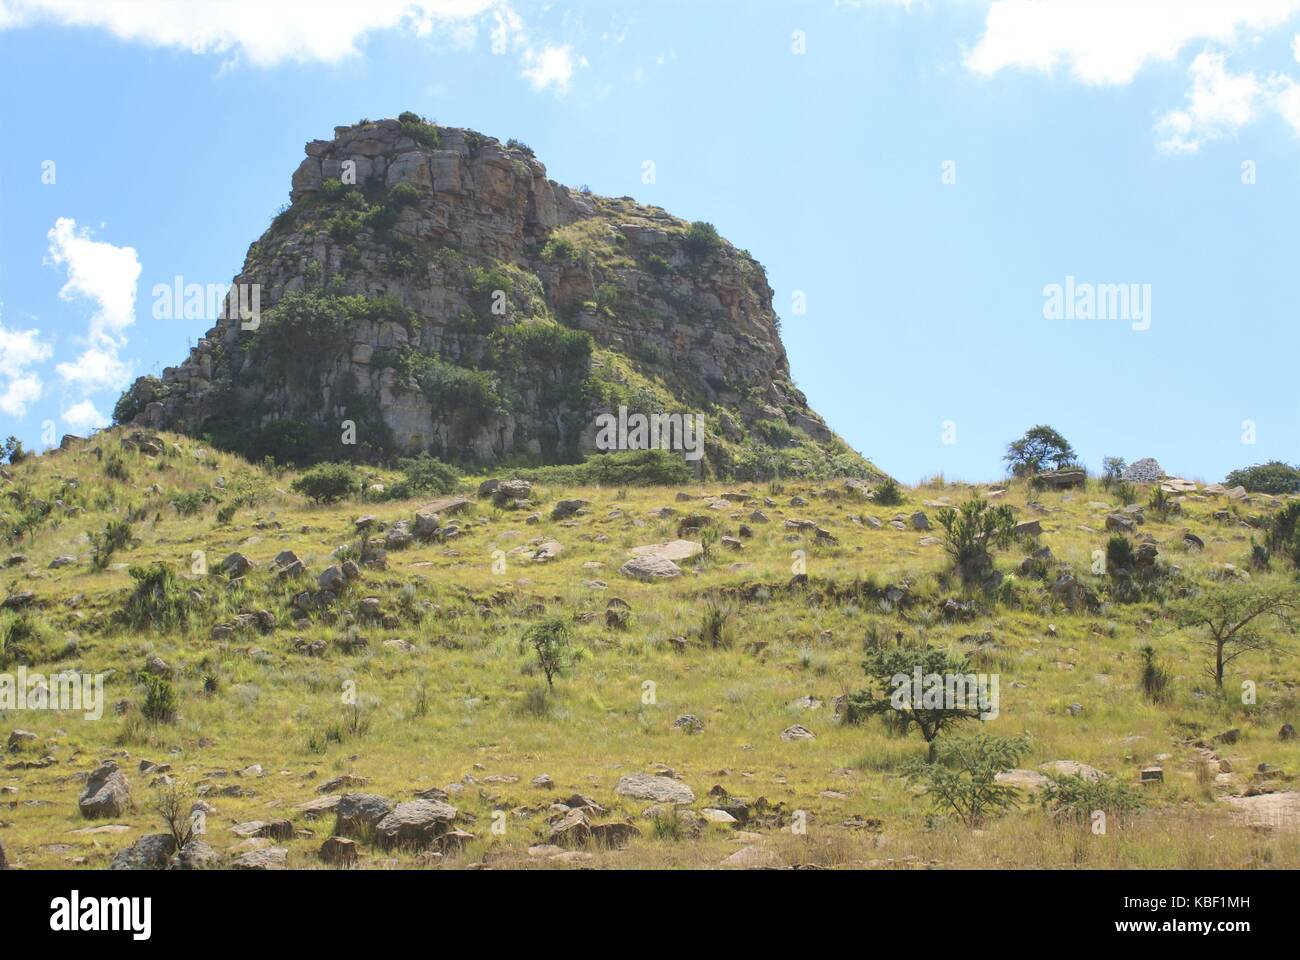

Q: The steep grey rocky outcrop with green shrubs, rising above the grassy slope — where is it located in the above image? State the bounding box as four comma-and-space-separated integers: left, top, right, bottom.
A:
116, 114, 874, 476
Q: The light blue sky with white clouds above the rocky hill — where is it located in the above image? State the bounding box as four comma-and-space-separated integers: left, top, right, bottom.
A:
0, 0, 1300, 481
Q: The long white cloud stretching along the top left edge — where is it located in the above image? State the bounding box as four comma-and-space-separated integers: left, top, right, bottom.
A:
0, 0, 577, 92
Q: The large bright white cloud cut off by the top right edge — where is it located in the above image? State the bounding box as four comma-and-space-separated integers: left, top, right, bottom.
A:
966, 0, 1300, 85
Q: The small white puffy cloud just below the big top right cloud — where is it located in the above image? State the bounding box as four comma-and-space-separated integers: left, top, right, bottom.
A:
1156, 52, 1264, 153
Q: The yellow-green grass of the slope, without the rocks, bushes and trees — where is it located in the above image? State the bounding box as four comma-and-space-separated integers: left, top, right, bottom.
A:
0, 431, 1300, 868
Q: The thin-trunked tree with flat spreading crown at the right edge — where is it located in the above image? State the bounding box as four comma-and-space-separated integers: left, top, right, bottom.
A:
1169, 583, 1300, 689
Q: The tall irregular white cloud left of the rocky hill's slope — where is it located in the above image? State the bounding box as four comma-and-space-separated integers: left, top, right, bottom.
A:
47, 217, 140, 393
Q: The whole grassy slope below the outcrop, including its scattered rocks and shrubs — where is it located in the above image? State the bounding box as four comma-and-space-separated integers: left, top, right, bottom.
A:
0, 428, 1300, 869
